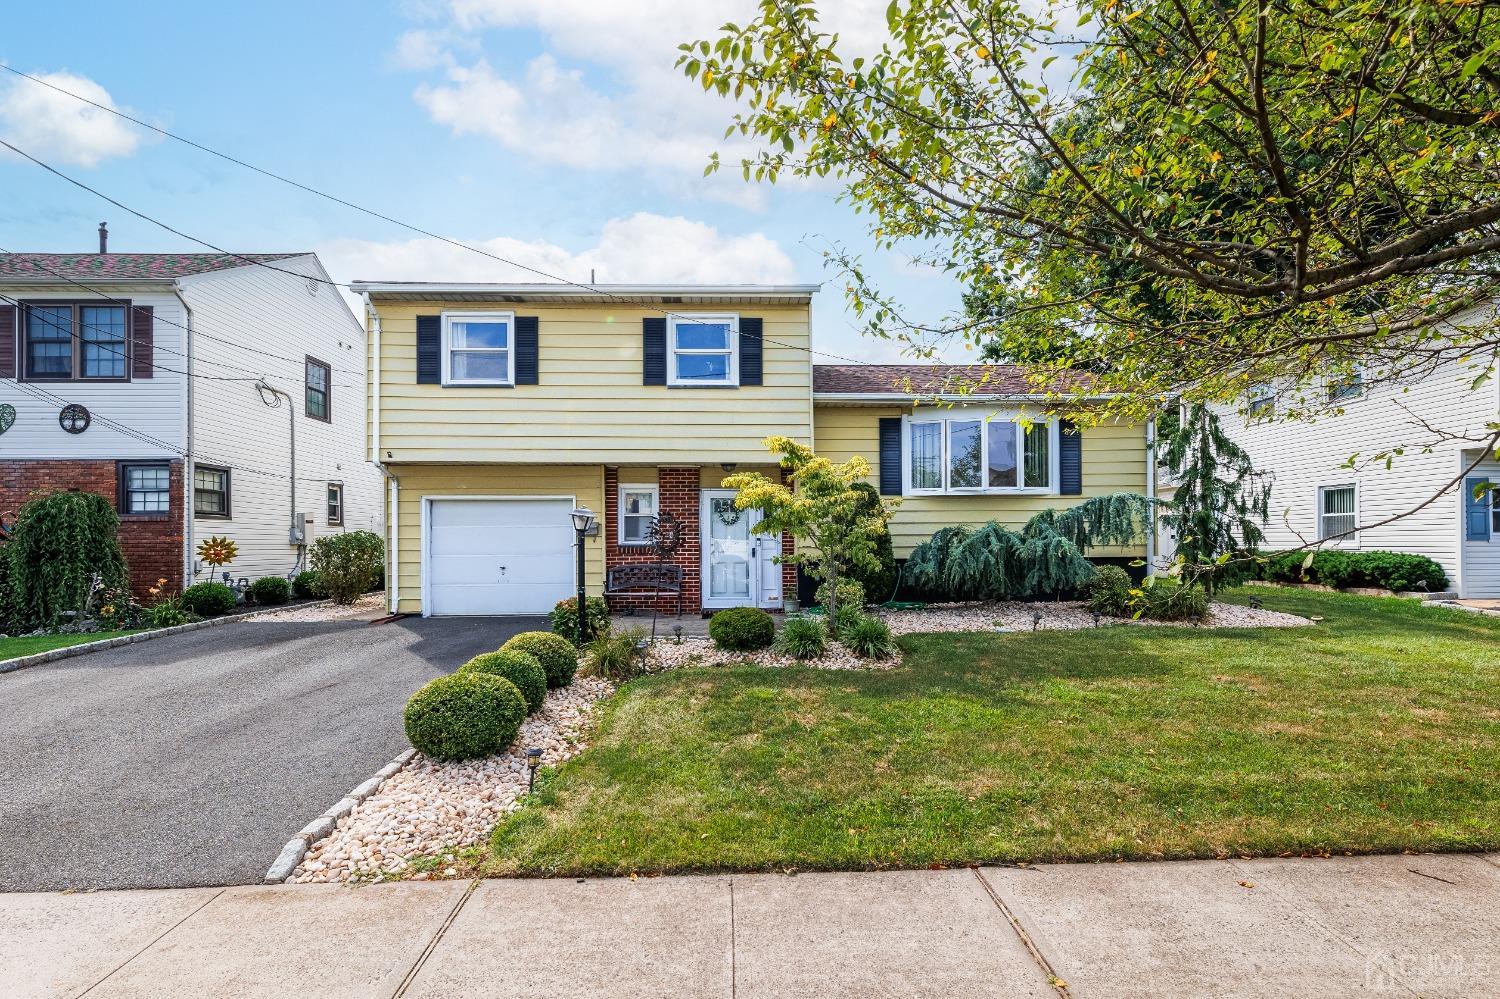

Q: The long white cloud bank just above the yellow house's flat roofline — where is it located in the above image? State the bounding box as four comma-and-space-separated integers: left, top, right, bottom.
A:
318, 212, 797, 285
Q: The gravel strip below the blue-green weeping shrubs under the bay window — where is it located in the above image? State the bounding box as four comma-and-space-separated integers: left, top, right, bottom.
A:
876, 600, 1313, 635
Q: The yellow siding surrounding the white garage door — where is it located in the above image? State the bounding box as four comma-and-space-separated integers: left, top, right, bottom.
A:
392, 465, 606, 614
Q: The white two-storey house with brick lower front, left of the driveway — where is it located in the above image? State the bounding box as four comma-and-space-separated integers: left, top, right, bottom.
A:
0, 234, 384, 591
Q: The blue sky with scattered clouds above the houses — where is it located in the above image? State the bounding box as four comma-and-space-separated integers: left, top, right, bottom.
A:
0, 0, 962, 360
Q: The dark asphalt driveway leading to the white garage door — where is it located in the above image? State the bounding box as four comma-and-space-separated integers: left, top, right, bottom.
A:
0, 618, 546, 891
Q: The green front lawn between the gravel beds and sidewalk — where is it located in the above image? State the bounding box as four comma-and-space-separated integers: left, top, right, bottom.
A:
477, 590, 1500, 875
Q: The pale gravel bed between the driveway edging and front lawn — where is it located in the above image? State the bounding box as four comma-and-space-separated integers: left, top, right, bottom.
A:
291, 677, 614, 884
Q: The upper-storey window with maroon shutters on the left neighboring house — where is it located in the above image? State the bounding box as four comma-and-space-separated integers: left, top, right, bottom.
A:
23, 303, 129, 381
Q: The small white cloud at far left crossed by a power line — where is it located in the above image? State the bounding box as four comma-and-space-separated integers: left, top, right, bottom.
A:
0, 72, 141, 167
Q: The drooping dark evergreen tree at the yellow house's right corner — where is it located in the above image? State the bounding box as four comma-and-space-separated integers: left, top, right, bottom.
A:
1161, 402, 1271, 597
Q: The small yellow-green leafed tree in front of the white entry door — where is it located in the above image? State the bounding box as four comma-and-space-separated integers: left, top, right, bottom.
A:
725, 437, 896, 621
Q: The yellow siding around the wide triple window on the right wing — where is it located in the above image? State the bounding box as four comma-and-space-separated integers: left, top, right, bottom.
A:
813, 404, 1146, 558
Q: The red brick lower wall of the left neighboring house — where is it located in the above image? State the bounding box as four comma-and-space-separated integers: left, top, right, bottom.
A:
0, 459, 183, 597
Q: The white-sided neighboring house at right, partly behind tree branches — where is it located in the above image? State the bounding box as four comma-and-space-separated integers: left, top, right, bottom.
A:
1221, 306, 1500, 597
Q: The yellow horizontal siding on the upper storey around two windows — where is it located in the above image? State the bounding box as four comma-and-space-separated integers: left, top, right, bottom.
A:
377, 302, 812, 465
